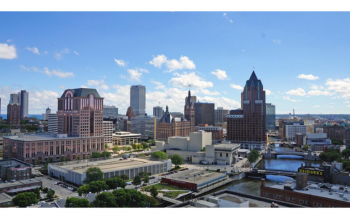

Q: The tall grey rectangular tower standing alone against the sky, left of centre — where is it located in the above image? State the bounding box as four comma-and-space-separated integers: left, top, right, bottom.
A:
130, 85, 146, 116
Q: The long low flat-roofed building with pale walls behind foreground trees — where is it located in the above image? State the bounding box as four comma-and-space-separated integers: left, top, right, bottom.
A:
48, 158, 171, 185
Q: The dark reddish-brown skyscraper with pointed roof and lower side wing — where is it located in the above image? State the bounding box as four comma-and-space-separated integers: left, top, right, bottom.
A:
226, 71, 266, 150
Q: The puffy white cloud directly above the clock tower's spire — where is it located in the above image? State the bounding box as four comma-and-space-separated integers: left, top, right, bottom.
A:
169, 72, 213, 88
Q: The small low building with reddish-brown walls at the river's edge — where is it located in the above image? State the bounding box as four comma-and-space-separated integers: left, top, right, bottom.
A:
162, 170, 227, 191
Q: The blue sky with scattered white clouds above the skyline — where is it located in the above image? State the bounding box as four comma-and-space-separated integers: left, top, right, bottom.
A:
0, 12, 350, 115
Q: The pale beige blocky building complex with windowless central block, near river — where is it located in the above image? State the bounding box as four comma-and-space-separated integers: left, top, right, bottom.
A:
155, 130, 241, 165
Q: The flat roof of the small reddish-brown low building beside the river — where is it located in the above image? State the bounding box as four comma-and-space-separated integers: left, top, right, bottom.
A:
164, 169, 226, 184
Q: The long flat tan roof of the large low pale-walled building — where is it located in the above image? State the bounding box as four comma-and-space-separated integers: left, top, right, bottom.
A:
49, 158, 163, 173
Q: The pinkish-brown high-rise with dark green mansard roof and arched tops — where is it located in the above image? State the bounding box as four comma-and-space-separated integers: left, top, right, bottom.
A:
57, 88, 103, 137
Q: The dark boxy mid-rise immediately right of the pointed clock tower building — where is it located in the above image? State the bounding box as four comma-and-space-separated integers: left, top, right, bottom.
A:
194, 102, 215, 126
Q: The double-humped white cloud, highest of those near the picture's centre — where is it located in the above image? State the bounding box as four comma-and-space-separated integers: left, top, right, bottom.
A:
149, 55, 196, 72
